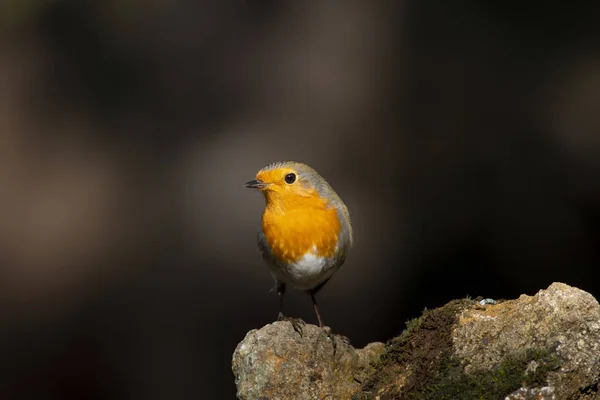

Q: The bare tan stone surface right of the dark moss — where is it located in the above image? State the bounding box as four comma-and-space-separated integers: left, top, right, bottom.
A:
452, 283, 600, 399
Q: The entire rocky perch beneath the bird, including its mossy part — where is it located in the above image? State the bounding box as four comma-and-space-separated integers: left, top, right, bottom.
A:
233, 283, 600, 400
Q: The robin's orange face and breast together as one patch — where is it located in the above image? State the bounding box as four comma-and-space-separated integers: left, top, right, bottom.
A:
249, 167, 341, 262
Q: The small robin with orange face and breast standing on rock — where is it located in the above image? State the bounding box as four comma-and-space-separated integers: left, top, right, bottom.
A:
244, 161, 353, 327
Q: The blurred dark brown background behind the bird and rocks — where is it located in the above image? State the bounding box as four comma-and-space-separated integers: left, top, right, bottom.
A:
0, 0, 600, 399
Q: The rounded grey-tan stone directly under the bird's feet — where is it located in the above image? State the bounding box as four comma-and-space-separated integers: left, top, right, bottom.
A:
233, 321, 384, 400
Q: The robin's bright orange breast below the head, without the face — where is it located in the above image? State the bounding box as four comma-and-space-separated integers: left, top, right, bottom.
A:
262, 200, 340, 262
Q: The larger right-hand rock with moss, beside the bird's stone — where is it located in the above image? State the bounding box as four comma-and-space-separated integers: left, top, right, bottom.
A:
355, 283, 600, 400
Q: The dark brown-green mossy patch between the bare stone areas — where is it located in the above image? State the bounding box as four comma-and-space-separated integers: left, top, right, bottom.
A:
353, 299, 560, 400
